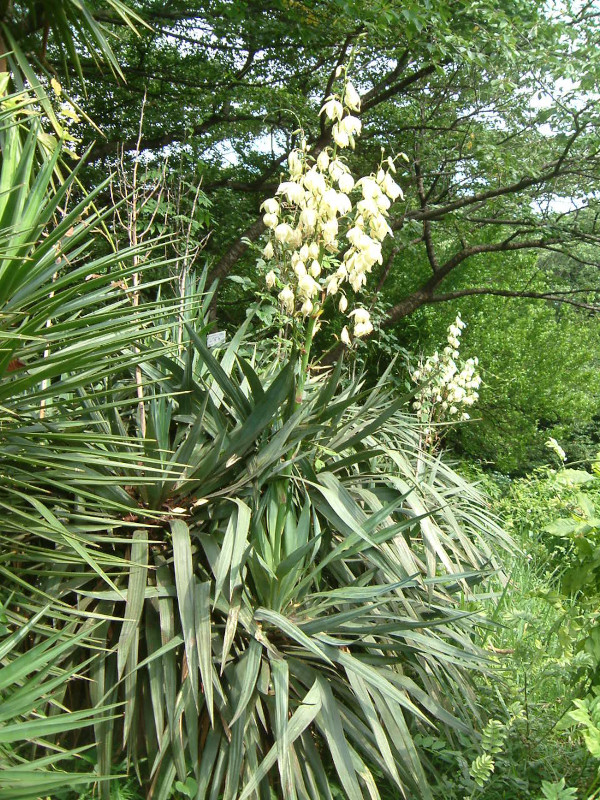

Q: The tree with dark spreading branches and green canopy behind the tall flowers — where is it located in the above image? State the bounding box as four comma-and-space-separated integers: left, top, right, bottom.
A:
9, 0, 599, 340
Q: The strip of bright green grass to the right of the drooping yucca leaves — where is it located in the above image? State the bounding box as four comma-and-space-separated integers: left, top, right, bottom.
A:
460, 470, 597, 800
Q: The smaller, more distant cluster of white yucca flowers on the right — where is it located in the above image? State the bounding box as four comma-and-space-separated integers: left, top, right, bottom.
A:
411, 314, 481, 435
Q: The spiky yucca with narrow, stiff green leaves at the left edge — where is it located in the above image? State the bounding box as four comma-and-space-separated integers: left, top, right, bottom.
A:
0, 93, 190, 798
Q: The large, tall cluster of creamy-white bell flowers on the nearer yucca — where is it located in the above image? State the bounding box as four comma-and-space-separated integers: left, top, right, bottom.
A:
261, 76, 402, 344
